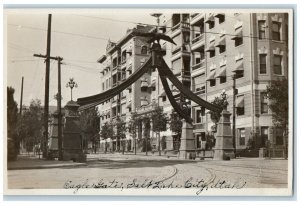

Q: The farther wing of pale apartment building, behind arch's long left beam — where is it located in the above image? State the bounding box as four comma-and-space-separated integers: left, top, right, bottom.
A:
98, 26, 156, 151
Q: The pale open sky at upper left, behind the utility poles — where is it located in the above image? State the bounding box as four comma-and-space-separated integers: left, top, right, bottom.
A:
4, 9, 156, 106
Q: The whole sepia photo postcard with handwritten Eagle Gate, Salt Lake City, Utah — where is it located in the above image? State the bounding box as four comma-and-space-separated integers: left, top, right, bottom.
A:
3, 8, 294, 196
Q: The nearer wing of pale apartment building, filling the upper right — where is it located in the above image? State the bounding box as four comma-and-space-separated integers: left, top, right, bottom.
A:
190, 13, 288, 156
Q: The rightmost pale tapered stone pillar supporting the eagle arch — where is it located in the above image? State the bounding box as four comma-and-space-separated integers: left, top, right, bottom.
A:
214, 110, 234, 160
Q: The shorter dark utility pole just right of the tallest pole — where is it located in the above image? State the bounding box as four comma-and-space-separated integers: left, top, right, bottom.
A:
57, 57, 63, 160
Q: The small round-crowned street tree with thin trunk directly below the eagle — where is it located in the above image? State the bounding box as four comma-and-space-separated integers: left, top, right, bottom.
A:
151, 106, 168, 156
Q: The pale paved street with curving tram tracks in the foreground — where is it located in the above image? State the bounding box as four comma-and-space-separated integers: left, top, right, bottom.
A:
8, 153, 287, 193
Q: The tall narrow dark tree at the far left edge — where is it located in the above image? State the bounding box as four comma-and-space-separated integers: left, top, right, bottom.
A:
7, 87, 20, 160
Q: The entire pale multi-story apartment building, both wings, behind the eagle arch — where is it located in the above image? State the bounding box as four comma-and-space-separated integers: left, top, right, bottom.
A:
99, 13, 288, 157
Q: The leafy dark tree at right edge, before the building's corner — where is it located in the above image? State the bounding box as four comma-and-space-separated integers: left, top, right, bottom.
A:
267, 78, 289, 159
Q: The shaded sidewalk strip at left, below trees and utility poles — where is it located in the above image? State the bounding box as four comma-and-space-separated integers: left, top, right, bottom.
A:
7, 154, 86, 170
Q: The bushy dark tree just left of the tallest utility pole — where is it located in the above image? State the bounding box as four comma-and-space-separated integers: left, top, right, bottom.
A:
21, 99, 44, 151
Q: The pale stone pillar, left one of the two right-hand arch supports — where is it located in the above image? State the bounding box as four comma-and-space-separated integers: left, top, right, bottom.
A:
179, 119, 195, 159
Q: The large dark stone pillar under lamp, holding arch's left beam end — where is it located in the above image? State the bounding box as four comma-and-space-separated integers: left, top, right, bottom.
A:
63, 101, 86, 162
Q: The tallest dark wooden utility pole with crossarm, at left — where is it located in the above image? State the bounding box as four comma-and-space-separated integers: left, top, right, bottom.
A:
33, 14, 52, 158
